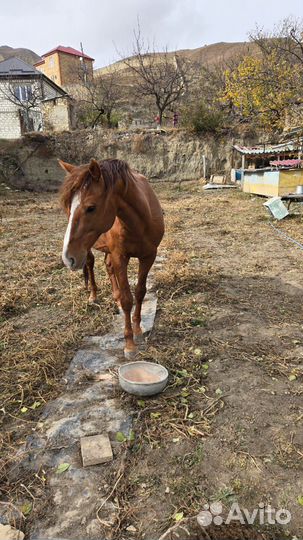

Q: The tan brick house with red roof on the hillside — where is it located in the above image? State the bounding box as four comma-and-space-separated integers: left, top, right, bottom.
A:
35, 45, 94, 87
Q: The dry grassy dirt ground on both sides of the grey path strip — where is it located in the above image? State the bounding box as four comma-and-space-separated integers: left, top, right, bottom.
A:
0, 179, 303, 540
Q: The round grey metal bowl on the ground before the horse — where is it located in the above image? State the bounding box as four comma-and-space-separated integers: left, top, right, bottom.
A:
119, 362, 168, 397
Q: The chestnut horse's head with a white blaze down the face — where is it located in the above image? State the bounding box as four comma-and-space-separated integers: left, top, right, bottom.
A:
59, 159, 116, 270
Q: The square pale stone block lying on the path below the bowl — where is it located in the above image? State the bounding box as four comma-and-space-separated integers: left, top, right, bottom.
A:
80, 434, 113, 467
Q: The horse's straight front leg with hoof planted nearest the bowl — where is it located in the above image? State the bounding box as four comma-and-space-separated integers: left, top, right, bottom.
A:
111, 254, 136, 358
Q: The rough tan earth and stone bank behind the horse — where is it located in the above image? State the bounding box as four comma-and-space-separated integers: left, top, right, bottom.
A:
0, 129, 253, 191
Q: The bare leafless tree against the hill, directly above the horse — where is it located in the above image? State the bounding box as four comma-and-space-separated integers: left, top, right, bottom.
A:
122, 23, 190, 125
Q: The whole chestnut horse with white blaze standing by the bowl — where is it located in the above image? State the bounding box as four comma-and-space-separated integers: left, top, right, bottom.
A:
59, 159, 164, 357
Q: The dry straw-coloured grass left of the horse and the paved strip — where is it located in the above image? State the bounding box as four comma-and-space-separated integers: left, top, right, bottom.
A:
0, 190, 113, 502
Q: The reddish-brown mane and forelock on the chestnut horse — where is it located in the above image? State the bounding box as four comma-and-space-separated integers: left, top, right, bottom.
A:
60, 159, 134, 210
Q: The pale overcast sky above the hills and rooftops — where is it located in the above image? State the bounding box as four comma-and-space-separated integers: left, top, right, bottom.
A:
0, 0, 303, 68
